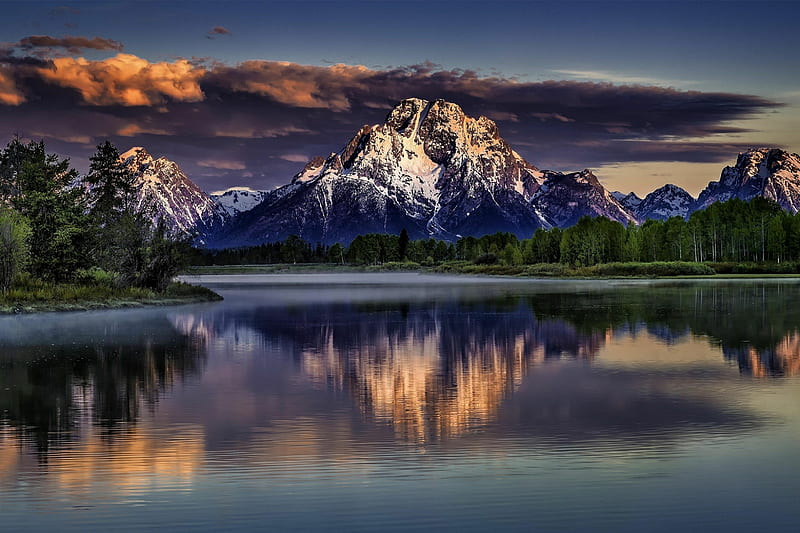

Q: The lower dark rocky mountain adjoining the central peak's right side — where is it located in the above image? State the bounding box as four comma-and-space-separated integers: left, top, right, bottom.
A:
532, 169, 636, 228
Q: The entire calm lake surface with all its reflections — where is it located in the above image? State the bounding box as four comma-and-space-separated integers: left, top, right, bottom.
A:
0, 274, 800, 532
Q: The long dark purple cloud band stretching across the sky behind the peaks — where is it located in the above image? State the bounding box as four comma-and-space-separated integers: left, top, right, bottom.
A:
0, 54, 779, 189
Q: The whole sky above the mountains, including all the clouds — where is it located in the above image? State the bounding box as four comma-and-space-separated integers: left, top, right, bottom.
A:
0, 0, 800, 195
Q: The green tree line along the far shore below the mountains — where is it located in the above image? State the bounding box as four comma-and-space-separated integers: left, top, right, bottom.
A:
194, 197, 800, 266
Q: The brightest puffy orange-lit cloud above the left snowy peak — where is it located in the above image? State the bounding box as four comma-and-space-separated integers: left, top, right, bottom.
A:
39, 54, 205, 106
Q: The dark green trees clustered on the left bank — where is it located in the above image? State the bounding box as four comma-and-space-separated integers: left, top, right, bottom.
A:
0, 138, 189, 294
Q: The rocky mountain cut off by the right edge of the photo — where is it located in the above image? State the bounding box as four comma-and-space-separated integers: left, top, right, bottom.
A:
693, 148, 800, 213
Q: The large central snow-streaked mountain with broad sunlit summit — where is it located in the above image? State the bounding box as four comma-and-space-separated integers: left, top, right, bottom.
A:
215, 98, 550, 246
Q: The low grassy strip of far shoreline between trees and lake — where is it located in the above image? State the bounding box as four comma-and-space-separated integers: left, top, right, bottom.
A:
183, 261, 800, 279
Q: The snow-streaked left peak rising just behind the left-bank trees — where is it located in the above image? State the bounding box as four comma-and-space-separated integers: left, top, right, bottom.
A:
120, 146, 230, 237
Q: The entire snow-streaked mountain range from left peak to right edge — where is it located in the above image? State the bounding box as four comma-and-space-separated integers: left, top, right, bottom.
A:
117, 98, 800, 248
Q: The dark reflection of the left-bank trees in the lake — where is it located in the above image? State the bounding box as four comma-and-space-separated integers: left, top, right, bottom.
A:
0, 312, 205, 457
